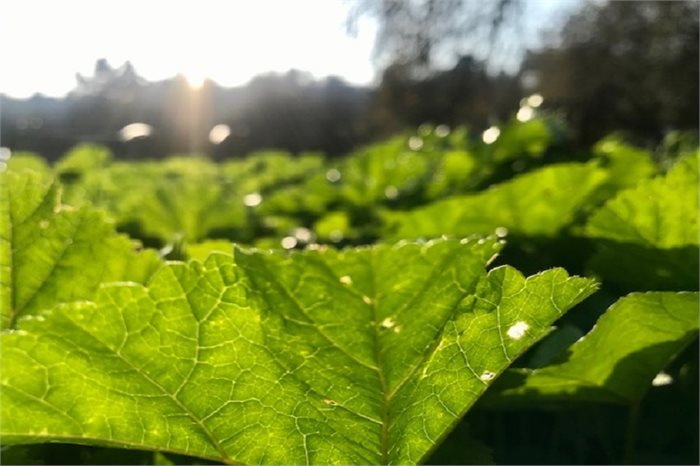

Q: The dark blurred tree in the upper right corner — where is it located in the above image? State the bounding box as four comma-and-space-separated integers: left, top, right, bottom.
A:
522, 1, 700, 143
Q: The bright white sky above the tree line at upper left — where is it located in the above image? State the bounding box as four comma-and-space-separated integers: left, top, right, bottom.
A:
0, 0, 377, 97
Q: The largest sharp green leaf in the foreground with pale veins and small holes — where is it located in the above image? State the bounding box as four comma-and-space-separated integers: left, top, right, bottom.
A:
1, 239, 595, 464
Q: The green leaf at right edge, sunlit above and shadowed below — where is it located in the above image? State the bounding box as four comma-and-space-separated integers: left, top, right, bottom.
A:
586, 155, 700, 290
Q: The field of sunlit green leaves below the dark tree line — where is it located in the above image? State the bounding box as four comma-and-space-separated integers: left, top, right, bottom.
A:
0, 116, 700, 464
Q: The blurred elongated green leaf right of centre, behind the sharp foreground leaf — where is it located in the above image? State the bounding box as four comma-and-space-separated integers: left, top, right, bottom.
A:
393, 163, 606, 238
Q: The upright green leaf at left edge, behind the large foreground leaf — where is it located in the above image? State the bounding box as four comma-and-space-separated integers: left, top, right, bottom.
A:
0, 172, 160, 329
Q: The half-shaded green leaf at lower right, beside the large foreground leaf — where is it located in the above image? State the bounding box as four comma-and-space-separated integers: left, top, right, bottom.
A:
487, 292, 699, 404
